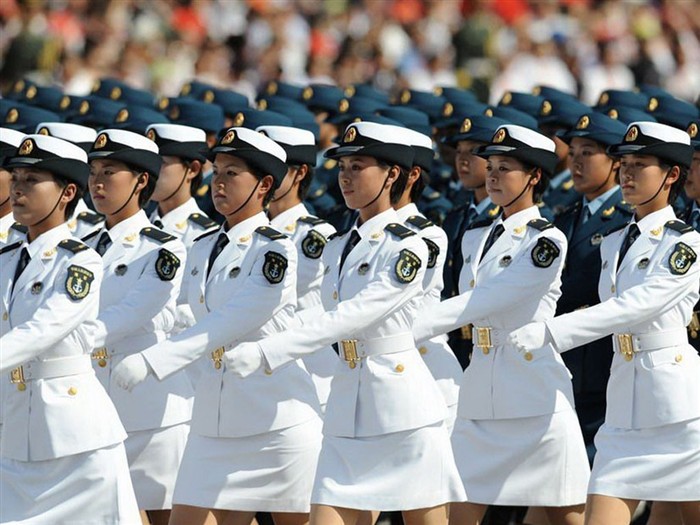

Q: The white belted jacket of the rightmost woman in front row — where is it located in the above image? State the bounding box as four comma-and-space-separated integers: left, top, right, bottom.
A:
547, 206, 700, 429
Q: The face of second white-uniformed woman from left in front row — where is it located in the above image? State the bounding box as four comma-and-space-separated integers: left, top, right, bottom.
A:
88, 159, 140, 216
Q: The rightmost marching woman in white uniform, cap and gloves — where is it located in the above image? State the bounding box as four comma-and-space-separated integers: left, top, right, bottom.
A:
510, 122, 700, 525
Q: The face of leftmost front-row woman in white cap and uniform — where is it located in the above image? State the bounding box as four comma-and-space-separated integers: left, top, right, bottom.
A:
10, 167, 65, 226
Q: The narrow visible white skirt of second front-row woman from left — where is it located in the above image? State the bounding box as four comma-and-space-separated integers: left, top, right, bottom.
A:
124, 423, 190, 510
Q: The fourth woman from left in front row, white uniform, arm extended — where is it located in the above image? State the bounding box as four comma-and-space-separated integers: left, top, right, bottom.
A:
226, 122, 464, 525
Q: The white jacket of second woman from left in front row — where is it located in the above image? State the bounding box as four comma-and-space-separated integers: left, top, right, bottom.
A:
86, 210, 194, 432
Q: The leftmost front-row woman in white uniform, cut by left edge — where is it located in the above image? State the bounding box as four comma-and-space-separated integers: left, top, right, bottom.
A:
0, 135, 140, 525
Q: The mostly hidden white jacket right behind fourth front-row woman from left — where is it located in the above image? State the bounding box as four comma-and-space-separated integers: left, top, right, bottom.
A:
396, 203, 462, 407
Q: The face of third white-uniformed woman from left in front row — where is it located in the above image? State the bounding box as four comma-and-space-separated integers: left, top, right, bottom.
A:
211, 153, 266, 215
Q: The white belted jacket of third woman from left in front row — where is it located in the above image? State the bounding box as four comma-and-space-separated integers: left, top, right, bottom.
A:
143, 212, 319, 437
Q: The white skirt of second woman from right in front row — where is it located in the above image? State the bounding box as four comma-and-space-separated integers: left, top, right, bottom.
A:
452, 410, 590, 507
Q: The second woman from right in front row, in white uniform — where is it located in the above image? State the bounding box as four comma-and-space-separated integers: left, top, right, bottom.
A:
414, 125, 589, 525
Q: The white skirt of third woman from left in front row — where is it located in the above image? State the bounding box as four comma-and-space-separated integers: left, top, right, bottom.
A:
173, 418, 322, 512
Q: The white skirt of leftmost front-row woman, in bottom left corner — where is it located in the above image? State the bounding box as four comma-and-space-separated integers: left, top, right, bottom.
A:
0, 443, 141, 525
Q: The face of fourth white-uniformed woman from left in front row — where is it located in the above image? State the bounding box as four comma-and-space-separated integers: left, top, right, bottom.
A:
338, 155, 389, 210
